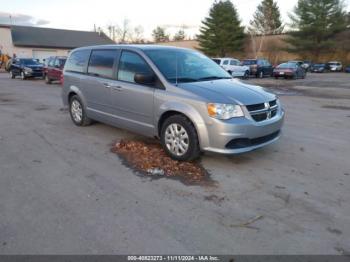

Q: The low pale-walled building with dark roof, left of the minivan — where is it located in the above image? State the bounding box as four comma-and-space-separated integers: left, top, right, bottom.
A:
0, 25, 114, 62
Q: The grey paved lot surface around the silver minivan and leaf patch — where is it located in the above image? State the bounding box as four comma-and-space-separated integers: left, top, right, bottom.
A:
0, 73, 350, 254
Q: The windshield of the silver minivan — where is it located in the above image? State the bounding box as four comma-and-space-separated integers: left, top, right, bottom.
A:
145, 49, 231, 83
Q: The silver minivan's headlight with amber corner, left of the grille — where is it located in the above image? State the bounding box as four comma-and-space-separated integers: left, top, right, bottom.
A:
207, 103, 244, 120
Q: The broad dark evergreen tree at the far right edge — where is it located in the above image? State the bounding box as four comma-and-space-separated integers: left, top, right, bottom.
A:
285, 0, 349, 60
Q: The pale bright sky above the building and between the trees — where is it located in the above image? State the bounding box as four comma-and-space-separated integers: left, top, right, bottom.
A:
0, 0, 350, 37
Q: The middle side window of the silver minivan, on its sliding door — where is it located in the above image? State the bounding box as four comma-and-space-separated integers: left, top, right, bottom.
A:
88, 50, 117, 78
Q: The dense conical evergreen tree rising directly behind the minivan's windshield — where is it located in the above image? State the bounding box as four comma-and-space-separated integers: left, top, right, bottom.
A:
197, 0, 245, 56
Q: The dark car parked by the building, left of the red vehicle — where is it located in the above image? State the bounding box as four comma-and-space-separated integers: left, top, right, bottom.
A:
9, 58, 44, 80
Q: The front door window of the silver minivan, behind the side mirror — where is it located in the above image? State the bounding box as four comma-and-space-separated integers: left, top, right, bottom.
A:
118, 51, 153, 83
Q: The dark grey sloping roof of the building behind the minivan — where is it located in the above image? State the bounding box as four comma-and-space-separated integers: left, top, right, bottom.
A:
11, 26, 114, 49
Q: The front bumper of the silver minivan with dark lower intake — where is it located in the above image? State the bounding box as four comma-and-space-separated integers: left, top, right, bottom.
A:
201, 108, 285, 154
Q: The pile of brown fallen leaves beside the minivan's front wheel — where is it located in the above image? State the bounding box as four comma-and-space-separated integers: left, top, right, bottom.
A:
112, 140, 212, 184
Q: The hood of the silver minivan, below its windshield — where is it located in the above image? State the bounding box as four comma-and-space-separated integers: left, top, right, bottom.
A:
179, 79, 276, 105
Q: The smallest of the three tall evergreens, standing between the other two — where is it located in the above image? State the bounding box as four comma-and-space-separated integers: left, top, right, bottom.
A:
249, 0, 284, 35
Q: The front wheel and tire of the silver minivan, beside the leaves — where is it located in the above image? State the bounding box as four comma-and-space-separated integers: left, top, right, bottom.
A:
160, 115, 200, 161
